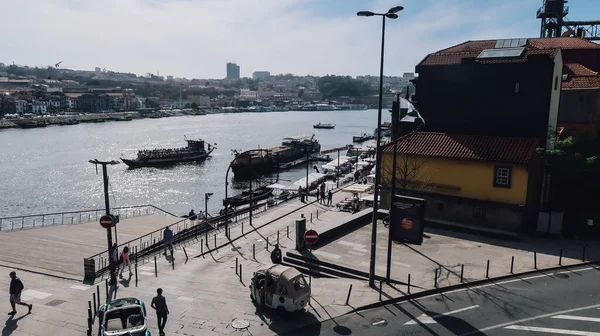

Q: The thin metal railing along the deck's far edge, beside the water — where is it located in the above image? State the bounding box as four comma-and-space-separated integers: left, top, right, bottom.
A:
0, 204, 178, 231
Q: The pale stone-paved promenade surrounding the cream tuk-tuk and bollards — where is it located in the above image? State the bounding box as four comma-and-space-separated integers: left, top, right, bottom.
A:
0, 186, 597, 336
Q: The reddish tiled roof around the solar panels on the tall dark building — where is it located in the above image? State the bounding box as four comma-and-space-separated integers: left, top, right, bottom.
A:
419, 37, 600, 65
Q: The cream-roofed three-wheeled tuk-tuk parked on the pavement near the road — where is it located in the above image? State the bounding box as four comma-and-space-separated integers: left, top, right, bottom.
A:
249, 265, 310, 312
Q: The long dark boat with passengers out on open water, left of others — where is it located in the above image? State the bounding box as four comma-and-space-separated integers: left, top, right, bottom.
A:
121, 138, 216, 168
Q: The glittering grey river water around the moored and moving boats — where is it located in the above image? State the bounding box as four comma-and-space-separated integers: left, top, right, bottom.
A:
0, 110, 389, 217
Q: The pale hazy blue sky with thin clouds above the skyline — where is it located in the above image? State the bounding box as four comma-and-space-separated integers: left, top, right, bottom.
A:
0, 0, 600, 78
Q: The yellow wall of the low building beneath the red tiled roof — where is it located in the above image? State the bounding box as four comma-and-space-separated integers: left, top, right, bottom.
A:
381, 153, 529, 205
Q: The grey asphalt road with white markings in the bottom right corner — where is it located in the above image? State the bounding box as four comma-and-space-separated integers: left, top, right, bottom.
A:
289, 266, 600, 336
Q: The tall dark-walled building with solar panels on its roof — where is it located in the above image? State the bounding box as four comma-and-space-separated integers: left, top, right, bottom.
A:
413, 37, 600, 146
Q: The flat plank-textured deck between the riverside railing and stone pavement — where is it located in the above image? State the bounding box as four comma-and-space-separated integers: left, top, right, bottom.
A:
0, 215, 180, 279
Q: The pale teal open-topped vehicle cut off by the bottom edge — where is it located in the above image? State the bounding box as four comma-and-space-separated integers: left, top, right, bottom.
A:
98, 298, 150, 336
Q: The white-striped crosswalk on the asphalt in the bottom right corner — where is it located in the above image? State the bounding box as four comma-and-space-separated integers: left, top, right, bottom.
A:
504, 308, 600, 336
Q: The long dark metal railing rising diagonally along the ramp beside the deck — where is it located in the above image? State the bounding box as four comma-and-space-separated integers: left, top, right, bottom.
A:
84, 194, 296, 278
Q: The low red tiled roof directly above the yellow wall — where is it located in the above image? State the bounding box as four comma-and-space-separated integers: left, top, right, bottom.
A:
382, 132, 538, 164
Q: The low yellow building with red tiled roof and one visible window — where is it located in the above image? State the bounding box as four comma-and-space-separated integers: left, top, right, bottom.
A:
381, 132, 540, 232
